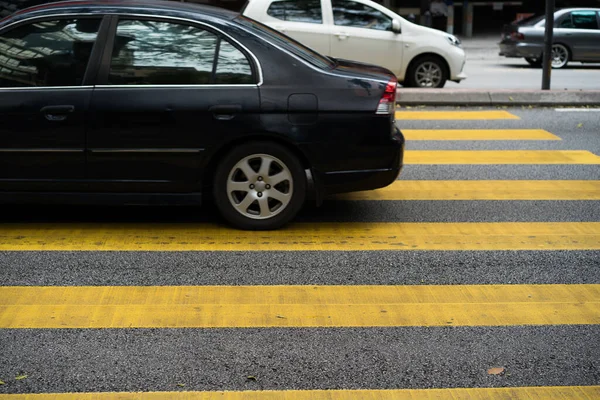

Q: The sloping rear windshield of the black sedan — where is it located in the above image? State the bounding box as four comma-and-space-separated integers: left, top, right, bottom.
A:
235, 15, 335, 69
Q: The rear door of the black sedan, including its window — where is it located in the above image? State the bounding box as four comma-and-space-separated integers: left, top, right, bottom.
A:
87, 17, 260, 192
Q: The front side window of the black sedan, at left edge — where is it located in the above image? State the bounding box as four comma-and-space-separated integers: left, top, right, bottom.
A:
0, 18, 101, 87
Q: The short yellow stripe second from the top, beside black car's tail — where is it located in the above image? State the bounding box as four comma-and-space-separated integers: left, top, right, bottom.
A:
402, 129, 561, 140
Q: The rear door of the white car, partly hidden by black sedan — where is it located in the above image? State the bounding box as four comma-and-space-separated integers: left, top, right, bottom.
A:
263, 0, 331, 55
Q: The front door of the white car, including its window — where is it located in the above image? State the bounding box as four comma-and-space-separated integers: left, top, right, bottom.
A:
330, 0, 403, 74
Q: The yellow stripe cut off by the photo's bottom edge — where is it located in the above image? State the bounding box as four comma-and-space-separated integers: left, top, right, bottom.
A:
0, 388, 600, 400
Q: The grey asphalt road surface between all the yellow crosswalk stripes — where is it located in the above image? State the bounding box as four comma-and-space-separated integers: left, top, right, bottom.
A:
0, 106, 600, 399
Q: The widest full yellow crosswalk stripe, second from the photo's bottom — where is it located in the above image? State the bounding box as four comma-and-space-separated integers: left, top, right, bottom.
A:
0, 284, 600, 329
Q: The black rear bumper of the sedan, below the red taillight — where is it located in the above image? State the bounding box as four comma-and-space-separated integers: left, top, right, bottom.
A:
314, 128, 404, 198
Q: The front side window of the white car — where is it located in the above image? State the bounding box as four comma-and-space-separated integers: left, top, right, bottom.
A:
331, 0, 392, 31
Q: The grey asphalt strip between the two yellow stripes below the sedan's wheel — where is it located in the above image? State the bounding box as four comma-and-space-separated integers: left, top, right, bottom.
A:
0, 251, 600, 288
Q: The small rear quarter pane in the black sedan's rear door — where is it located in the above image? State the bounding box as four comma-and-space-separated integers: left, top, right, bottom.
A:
214, 41, 254, 84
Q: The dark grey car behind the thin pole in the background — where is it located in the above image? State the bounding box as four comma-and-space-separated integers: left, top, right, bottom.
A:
499, 8, 600, 68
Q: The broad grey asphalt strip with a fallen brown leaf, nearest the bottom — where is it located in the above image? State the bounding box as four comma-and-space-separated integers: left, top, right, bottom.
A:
0, 325, 600, 393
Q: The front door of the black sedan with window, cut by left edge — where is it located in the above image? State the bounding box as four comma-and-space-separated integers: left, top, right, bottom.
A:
0, 16, 107, 191
